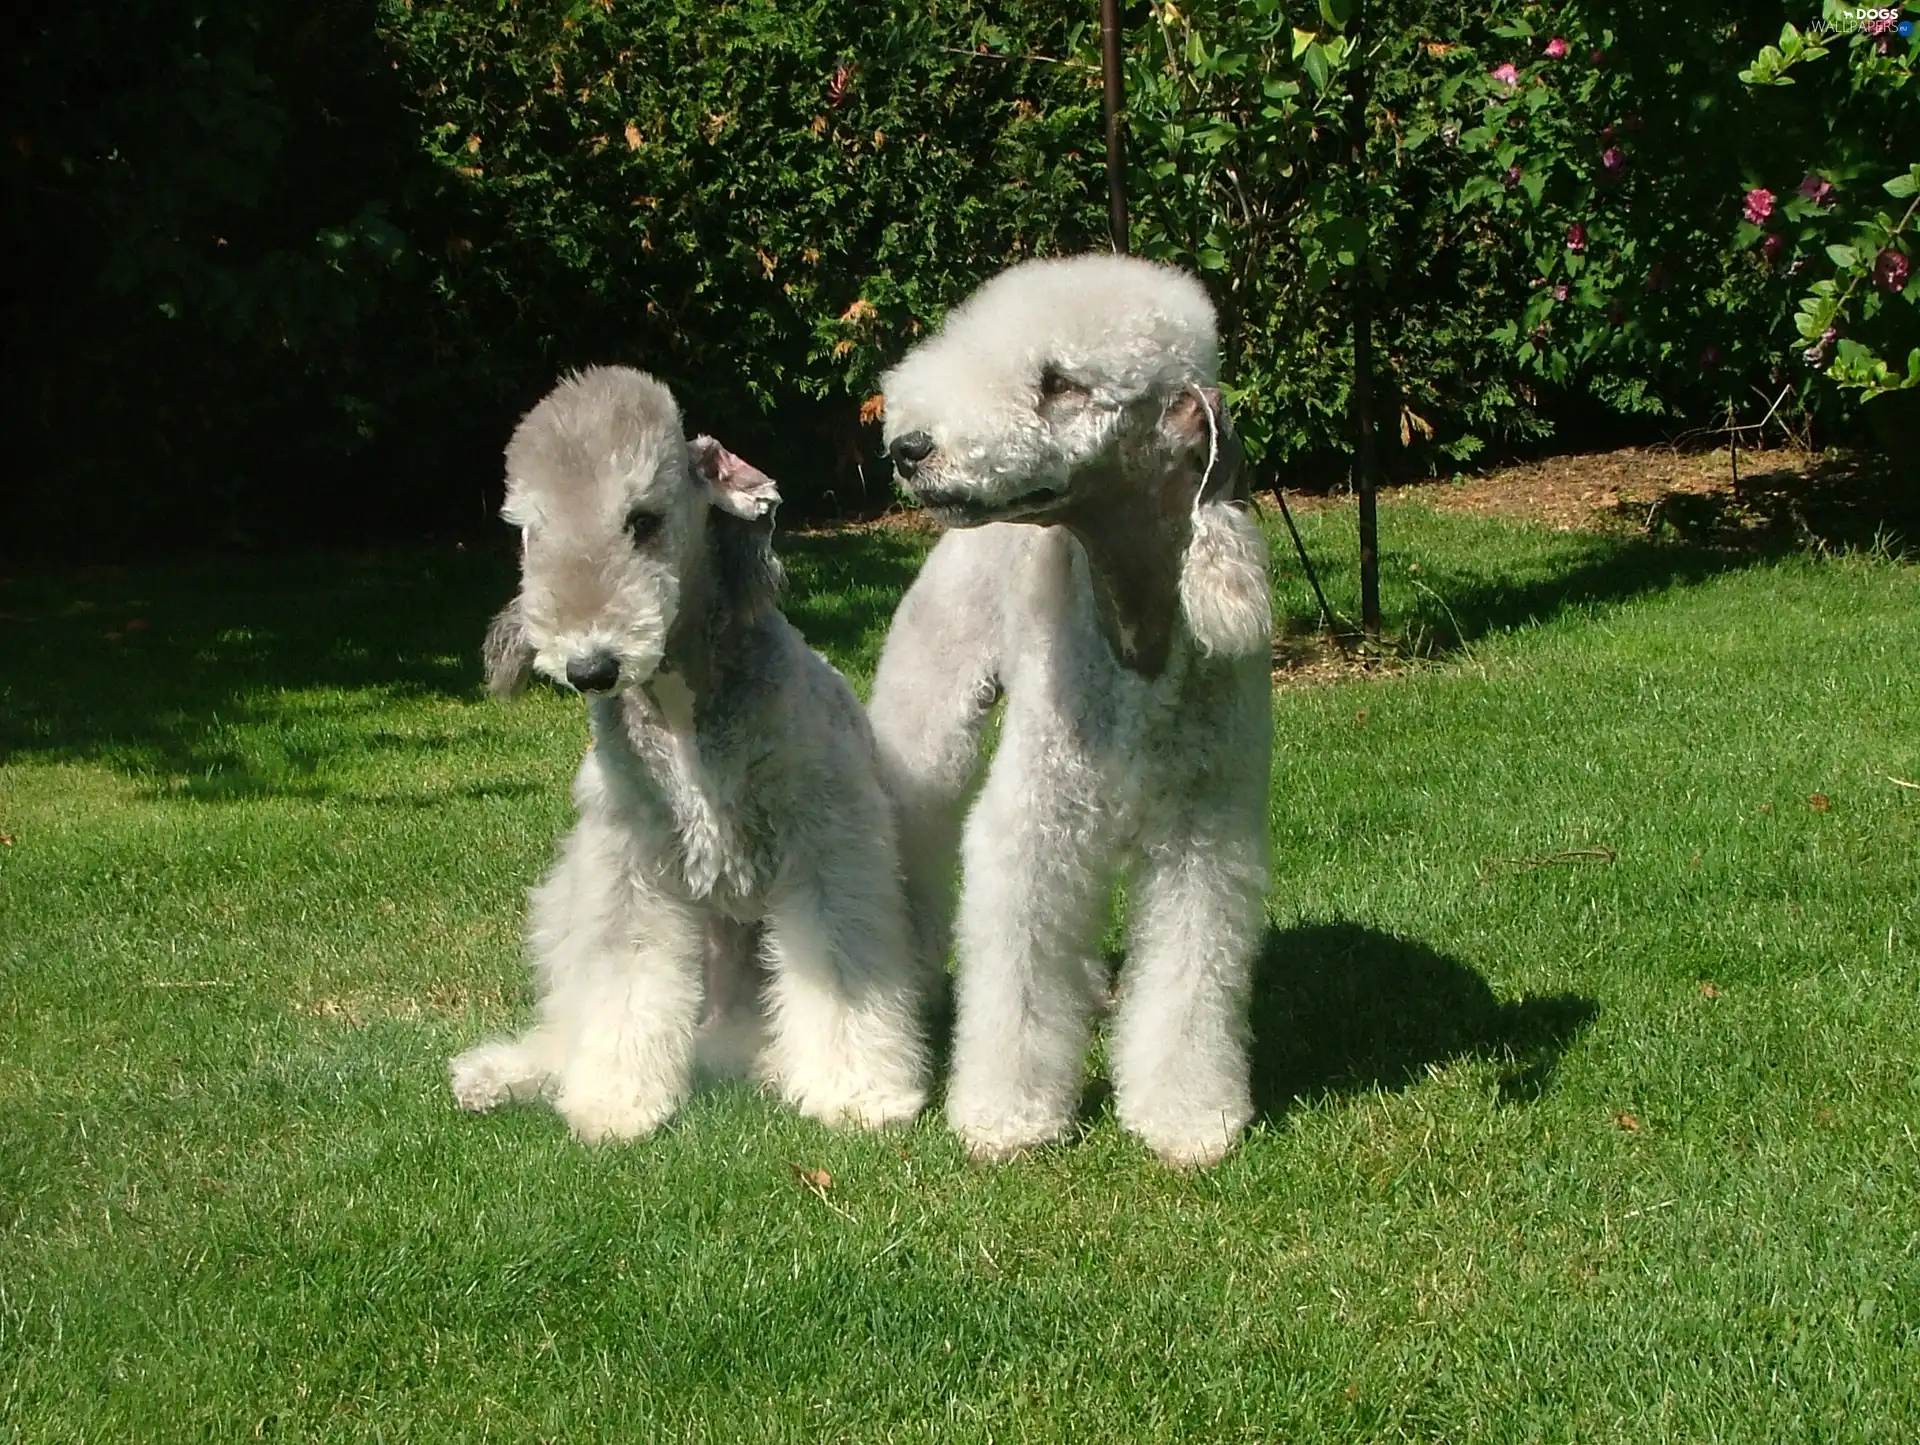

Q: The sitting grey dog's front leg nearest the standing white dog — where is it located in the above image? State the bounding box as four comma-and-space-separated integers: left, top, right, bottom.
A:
762, 844, 927, 1128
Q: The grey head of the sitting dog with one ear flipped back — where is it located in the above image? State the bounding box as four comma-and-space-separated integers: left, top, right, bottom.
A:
484, 367, 780, 695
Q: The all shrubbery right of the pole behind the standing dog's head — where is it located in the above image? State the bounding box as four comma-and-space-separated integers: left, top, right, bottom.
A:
1127, 0, 1920, 468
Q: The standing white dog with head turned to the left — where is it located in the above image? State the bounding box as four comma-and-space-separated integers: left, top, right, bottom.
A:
870, 257, 1273, 1165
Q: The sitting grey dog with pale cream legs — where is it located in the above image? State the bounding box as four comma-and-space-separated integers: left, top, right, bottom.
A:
451, 367, 927, 1140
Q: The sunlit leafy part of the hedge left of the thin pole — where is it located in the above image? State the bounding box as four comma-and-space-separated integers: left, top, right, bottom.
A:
382, 0, 1100, 456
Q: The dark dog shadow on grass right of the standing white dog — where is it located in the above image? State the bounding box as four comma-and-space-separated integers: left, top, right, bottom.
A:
1252, 923, 1599, 1119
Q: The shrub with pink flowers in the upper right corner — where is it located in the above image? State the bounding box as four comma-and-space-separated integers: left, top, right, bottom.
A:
1430, 0, 1920, 426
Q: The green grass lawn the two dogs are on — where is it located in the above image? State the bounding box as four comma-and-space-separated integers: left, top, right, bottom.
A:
0, 503, 1920, 1445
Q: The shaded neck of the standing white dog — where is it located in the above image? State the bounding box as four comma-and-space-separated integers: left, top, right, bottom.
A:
1048, 461, 1194, 677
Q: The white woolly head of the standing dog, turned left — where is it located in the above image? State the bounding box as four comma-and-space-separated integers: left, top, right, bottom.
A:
883, 255, 1231, 526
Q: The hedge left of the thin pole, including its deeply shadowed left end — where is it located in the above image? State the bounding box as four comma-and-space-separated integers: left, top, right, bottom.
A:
0, 0, 1102, 557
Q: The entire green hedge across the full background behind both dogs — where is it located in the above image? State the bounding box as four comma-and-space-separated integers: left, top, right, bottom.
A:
0, 0, 1920, 557
